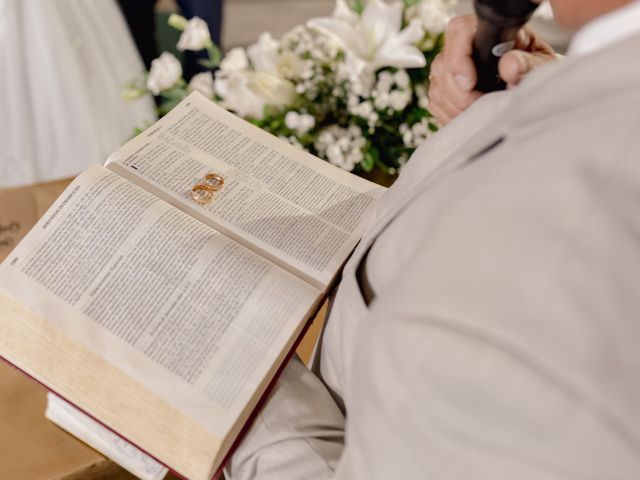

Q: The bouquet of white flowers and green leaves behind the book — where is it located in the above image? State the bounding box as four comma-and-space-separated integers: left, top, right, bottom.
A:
126, 0, 455, 182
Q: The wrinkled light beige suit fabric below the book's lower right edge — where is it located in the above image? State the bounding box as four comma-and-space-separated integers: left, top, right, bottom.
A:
225, 356, 345, 480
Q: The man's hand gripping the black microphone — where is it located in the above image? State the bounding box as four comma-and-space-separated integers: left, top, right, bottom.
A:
429, 15, 556, 125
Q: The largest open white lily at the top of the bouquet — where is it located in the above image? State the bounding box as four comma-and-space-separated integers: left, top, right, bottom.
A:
307, 0, 426, 70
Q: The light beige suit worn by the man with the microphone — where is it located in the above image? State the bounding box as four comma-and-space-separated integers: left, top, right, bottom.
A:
228, 31, 640, 480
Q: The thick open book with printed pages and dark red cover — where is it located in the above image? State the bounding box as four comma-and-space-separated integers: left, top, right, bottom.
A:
0, 93, 384, 480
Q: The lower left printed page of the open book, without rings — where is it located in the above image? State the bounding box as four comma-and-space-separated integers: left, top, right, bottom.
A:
0, 166, 320, 438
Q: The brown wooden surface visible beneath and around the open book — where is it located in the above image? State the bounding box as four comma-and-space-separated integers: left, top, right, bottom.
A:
0, 180, 326, 480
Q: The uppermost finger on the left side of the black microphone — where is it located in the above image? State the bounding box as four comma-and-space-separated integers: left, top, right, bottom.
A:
444, 15, 478, 92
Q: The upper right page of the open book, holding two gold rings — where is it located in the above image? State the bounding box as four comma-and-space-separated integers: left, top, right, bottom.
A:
107, 93, 384, 288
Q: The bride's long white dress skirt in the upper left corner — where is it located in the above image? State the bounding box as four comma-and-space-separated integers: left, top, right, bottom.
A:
0, 0, 155, 188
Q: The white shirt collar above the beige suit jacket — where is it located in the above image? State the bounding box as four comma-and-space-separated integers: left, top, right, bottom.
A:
568, 0, 640, 55
